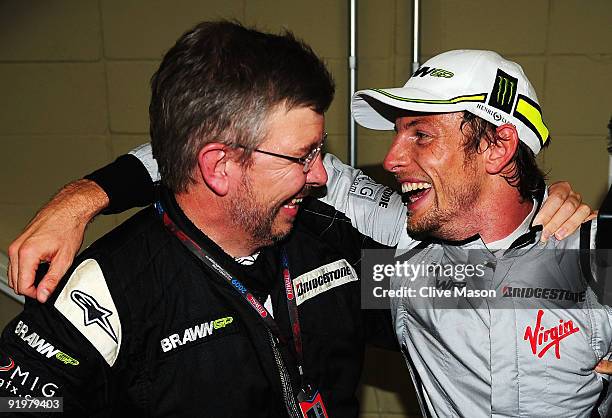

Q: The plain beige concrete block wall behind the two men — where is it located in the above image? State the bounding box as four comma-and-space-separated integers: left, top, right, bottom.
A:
0, 0, 612, 418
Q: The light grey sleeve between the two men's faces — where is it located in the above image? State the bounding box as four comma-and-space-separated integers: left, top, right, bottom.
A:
321, 154, 407, 246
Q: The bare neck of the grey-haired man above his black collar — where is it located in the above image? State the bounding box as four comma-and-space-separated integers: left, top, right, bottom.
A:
175, 189, 259, 258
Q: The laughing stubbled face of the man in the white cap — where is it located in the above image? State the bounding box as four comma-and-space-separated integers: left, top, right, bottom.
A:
383, 112, 485, 240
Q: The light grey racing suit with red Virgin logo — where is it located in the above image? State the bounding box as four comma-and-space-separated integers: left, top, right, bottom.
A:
133, 148, 612, 417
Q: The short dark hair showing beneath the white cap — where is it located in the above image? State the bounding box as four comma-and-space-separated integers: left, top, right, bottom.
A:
460, 111, 550, 200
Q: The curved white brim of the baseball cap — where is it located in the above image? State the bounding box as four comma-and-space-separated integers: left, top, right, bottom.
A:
351, 87, 484, 130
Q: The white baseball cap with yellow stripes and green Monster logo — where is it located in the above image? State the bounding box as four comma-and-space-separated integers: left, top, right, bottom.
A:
351, 49, 550, 154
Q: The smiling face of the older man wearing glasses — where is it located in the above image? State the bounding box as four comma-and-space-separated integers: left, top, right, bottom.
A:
227, 105, 327, 246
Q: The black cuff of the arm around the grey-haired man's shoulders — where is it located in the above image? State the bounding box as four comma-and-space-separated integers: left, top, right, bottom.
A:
85, 144, 159, 214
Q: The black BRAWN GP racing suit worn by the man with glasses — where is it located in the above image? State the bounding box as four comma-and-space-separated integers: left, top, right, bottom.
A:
0, 156, 395, 417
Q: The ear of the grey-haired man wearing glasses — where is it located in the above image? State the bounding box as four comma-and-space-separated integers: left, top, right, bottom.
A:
198, 142, 231, 196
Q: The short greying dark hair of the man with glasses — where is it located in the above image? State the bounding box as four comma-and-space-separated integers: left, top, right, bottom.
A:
149, 21, 334, 192
